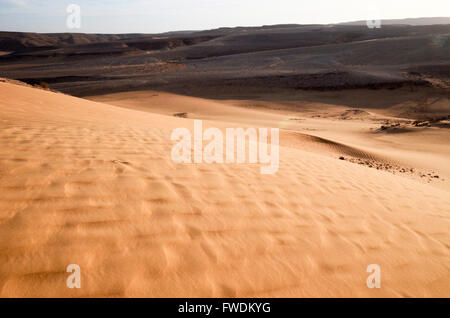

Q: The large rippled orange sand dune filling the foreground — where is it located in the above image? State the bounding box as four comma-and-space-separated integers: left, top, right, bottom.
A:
0, 83, 450, 297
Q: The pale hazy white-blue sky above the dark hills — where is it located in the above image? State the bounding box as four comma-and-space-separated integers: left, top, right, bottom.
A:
0, 0, 450, 33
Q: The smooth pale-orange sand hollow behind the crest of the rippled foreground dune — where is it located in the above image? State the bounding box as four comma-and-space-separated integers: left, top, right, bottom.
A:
87, 90, 450, 190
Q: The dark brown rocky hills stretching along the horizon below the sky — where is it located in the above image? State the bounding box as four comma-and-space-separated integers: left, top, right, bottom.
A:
0, 18, 450, 96
